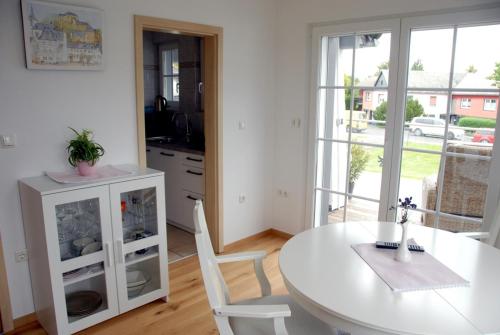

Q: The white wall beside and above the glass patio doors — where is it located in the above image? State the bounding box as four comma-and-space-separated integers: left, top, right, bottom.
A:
273, 0, 498, 234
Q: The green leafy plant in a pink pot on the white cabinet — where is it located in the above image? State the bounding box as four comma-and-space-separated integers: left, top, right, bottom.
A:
66, 127, 104, 176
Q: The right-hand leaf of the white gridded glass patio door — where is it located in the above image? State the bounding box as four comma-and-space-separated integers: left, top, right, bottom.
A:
392, 14, 500, 232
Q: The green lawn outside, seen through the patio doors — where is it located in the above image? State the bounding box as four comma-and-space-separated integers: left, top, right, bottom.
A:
365, 142, 441, 179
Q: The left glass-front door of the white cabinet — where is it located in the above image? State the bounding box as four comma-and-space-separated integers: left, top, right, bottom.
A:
43, 186, 118, 332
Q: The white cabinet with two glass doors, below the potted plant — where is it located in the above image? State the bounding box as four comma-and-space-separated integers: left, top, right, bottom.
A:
20, 166, 168, 334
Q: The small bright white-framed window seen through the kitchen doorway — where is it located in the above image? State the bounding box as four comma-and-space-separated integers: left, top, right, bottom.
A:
160, 45, 180, 102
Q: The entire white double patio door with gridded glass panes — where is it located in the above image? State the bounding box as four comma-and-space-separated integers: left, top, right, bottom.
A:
308, 9, 500, 232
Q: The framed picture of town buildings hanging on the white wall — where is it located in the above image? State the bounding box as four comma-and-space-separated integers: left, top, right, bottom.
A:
21, 0, 103, 70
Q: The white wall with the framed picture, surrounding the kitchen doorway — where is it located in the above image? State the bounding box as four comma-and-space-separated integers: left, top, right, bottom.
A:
0, 0, 276, 317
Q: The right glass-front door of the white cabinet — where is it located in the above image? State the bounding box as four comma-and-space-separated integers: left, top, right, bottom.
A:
110, 177, 168, 313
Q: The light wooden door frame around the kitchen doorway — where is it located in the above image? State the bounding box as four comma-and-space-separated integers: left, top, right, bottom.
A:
134, 15, 224, 252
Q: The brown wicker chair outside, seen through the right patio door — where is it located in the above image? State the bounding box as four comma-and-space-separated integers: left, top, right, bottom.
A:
422, 144, 492, 232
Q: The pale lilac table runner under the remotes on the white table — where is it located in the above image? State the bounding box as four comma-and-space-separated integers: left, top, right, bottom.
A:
352, 243, 469, 291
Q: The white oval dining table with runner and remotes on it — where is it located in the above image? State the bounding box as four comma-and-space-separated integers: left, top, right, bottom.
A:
279, 222, 500, 335
